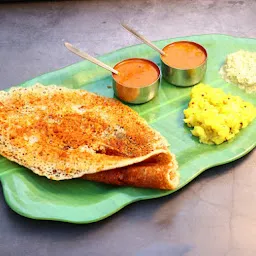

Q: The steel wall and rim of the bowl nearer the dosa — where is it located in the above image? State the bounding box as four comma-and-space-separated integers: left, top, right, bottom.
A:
112, 58, 161, 104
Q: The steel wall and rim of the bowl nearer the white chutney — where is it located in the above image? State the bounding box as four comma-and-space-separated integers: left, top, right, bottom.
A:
160, 41, 207, 87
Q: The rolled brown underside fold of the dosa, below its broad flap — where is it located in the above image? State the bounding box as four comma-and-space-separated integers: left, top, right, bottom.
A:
82, 154, 179, 190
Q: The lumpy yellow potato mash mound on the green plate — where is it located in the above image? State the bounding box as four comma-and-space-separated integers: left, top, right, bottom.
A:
184, 84, 256, 144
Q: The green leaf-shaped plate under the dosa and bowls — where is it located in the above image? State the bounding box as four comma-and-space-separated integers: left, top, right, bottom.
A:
0, 35, 256, 223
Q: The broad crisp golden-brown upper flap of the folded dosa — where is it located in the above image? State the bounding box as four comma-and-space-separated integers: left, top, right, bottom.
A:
0, 84, 178, 188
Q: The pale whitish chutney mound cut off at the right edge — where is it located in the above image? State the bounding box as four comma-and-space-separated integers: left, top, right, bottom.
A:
220, 50, 256, 93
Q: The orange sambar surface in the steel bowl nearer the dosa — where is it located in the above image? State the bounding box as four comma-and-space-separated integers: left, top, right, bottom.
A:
113, 58, 160, 88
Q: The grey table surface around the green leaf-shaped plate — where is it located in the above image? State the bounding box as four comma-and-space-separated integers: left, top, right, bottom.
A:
0, 0, 256, 256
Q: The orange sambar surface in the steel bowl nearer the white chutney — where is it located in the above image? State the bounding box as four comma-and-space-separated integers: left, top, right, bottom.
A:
161, 41, 207, 69
